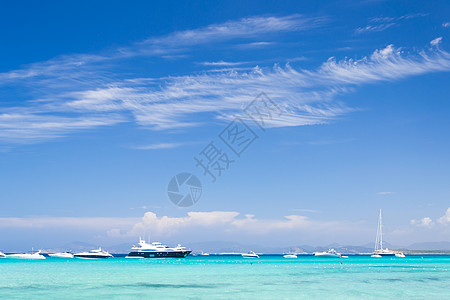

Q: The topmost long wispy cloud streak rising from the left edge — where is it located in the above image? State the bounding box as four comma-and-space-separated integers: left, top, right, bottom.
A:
0, 14, 326, 85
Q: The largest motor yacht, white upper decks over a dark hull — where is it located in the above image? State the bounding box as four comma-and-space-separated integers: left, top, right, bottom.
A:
126, 238, 191, 258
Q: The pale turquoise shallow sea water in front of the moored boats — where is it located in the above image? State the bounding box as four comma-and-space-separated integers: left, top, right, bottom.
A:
0, 256, 450, 299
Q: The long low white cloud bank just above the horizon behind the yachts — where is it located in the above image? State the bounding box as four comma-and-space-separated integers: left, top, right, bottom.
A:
0, 211, 366, 243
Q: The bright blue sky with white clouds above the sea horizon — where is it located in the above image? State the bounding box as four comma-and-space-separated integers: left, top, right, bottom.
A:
0, 1, 450, 250
